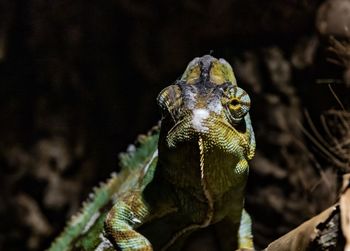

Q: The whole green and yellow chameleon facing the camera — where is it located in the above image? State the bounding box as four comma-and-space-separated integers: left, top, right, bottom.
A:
48, 55, 256, 251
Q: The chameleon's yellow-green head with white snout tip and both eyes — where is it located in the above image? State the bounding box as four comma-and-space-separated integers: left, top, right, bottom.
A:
158, 55, 255, 159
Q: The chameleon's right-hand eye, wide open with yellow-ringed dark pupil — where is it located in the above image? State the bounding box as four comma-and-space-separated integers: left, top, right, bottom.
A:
228, 86, 250, 122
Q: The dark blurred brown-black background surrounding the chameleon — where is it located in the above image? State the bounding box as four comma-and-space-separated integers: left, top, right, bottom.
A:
0, 0, 350, 250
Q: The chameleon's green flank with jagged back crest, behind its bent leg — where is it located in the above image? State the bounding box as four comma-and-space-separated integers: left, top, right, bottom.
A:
48, 131, 159, 251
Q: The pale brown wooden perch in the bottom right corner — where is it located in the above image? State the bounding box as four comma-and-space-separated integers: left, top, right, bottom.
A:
264, 174, 350, 251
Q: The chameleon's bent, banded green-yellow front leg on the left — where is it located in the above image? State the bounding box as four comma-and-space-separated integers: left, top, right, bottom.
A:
105, 191, 153, 251
